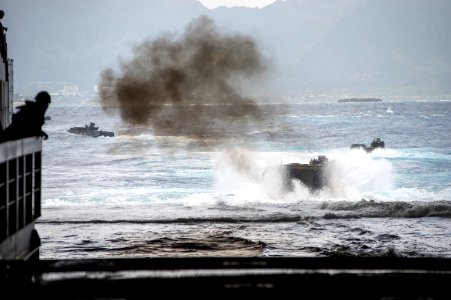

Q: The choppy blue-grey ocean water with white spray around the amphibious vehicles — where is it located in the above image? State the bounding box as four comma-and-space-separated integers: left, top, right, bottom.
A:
36, 96, 451, 259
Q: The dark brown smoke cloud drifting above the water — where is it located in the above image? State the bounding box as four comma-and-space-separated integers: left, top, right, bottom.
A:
100, 17, 265, 138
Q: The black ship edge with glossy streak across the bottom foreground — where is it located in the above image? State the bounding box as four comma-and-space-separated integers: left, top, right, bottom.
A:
0, 257, 451, 299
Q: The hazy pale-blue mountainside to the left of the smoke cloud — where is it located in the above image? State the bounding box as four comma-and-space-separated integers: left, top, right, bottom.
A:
4, 0, 206, 91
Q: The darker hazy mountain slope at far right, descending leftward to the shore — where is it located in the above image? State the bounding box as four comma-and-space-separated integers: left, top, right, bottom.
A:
287, 0, 451, 95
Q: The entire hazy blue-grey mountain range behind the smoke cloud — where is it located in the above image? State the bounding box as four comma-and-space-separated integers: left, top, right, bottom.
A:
1, 0, 451, 96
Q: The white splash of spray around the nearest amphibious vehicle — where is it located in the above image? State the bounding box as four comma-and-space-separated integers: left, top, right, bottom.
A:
215, 149, 394, 203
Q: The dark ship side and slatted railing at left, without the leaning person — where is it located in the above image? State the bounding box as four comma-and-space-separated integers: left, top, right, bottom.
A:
0, 11, 42, 260
